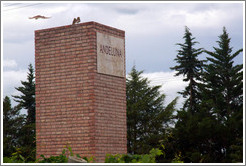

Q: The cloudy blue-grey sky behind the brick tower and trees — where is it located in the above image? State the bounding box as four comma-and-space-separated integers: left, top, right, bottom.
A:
1, 1, 245, 110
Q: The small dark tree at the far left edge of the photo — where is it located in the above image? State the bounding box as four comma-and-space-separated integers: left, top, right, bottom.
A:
3, 96, 24, 157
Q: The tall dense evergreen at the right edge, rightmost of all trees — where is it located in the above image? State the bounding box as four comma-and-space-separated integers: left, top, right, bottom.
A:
203, 27, 243, 162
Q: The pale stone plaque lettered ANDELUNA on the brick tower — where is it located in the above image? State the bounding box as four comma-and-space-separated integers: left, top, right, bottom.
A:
97, 32, 125, 77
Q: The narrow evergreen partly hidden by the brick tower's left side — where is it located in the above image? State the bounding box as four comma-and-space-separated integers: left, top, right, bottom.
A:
13, 64, 36, 161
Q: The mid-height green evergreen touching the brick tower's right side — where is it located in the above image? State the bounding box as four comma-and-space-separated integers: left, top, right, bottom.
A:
126, 66, 177, 154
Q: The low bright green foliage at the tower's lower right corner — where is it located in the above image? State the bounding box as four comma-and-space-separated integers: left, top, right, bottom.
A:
105, 148, 163, 163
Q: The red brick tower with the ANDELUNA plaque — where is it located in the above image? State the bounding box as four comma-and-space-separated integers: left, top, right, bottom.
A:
35, 22, 127, 162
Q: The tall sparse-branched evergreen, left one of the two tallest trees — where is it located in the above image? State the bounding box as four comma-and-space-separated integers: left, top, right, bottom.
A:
170, 27, 207, 162
